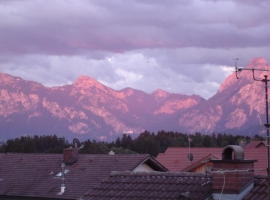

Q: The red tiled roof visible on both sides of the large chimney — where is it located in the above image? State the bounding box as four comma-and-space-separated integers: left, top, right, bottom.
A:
156, 147, 267, 174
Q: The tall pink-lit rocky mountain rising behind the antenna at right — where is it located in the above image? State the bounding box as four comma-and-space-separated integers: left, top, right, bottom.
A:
177, 58, 270, 135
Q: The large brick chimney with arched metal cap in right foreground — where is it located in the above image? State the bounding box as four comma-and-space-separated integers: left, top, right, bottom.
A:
211, 145, 257, 200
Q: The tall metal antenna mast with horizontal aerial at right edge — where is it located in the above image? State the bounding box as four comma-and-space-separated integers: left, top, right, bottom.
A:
235, 58, 270, 200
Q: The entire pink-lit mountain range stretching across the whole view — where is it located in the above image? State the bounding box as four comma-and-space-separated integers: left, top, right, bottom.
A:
0, 58, 270, 140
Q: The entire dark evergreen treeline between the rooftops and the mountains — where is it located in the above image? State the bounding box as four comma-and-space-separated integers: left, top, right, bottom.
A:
0, 131, 264, 156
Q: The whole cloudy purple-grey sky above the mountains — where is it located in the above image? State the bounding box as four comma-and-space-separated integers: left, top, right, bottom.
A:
0, 0, 270, 99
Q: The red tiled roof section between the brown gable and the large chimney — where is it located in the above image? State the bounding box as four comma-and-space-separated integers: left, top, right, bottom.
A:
156, 147, 223, 172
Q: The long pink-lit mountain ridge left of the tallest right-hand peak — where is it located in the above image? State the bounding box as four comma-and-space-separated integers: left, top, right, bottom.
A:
0, 73, 204, 140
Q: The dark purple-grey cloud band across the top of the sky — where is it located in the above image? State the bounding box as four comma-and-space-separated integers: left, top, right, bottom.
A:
1, 1, 270, 54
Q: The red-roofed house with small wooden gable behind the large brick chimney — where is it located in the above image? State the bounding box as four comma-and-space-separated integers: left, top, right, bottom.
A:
156, 141, 267, 175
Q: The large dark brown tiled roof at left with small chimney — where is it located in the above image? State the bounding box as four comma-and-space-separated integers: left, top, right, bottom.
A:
0, 154, 165, 199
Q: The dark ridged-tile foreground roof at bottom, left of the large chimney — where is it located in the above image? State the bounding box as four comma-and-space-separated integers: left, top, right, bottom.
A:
84, 172, 212, 200
